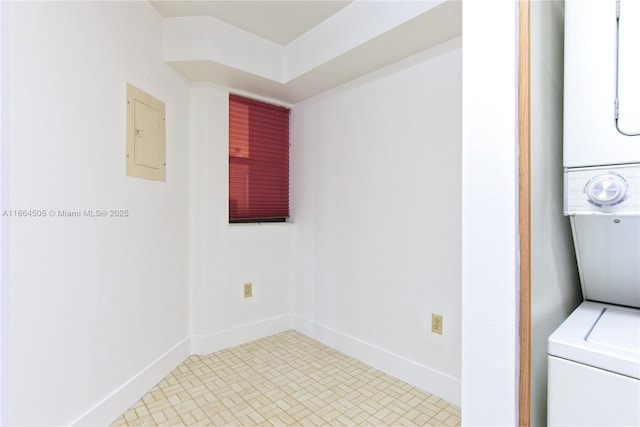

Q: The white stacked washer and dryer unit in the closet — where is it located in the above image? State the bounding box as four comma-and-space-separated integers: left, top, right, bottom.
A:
547, 0, 640, 426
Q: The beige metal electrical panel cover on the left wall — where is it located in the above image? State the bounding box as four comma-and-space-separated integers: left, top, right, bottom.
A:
127, 83, 167, 181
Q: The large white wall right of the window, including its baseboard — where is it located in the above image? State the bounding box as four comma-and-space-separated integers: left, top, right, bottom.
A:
291, 39, 461, 403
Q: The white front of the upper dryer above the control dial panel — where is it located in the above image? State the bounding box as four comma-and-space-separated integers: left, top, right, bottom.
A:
564, 0, 640, 167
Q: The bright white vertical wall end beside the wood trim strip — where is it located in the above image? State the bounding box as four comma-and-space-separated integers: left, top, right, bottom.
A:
462, 0, 519, 426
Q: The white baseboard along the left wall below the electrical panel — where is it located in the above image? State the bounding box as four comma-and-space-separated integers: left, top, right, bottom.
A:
71, 337, 190, 426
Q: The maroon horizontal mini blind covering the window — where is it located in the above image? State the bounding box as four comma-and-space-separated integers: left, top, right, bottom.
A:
229, 95, 289, 222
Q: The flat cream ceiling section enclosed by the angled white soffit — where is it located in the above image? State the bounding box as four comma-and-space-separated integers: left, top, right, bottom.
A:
151, 0, 351, 46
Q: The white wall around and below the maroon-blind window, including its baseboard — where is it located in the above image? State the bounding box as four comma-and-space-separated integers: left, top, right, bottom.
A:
190, 84, 294, 354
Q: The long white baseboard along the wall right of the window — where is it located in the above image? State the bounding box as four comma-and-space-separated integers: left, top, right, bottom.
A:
293, 317, 462, 406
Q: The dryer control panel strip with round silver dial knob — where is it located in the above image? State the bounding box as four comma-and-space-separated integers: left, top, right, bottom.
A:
564, 164, 640, 215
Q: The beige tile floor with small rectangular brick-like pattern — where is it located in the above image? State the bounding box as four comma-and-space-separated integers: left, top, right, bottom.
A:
112, 331, 460, 426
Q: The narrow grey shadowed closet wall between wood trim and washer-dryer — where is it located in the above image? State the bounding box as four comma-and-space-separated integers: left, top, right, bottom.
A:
531, 1, 582, 426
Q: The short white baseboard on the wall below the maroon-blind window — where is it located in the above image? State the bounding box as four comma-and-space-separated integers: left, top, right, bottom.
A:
191, 314, 292, 355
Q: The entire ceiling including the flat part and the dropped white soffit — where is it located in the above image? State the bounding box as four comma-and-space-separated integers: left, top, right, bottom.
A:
150, 0, 462, 105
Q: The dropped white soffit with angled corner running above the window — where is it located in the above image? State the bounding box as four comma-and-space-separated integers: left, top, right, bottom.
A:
163, 0, 462, 103
